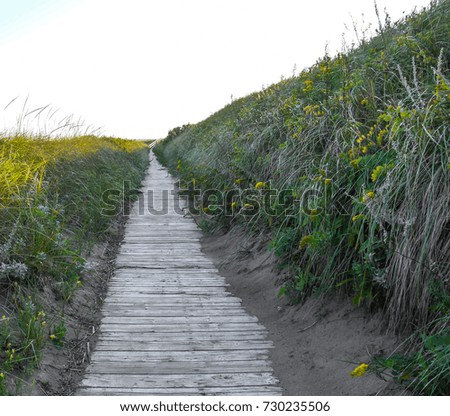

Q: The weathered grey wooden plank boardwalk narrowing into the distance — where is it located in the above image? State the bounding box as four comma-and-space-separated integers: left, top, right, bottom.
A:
78, 156, 281, 395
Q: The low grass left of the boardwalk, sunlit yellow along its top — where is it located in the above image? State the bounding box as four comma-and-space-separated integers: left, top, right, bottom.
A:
0, 135, 148, 394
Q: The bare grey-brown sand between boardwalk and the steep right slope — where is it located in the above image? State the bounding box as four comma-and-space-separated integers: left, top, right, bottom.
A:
202, 228, 403, 396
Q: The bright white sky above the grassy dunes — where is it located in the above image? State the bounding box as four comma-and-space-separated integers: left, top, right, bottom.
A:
0, 0, 429, 139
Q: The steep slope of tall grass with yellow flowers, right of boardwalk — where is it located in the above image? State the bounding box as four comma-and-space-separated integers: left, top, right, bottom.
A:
155, 0, 450, 394
